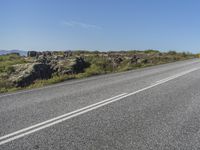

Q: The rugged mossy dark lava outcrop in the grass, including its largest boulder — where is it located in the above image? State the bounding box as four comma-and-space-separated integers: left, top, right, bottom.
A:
9, 56, 89, 87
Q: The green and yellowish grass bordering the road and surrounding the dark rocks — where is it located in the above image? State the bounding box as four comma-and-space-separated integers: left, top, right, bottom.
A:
0, 50, 197, 93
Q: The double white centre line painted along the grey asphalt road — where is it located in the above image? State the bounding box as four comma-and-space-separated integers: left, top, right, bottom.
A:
0, 68, 199, 145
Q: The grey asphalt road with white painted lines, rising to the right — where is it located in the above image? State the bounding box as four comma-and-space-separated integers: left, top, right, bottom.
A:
0, 59, 200, 150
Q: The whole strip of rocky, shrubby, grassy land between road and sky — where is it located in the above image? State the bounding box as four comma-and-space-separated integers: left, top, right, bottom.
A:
0, 50, 198, 93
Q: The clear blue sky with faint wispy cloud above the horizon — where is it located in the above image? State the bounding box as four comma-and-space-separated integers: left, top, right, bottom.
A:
0, 0, 200, 52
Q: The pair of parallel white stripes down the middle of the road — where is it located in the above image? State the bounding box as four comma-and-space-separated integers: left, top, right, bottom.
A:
0, 68, 199, 145
